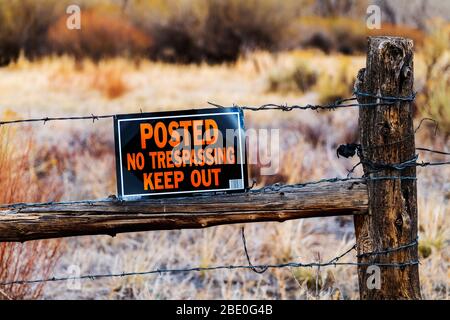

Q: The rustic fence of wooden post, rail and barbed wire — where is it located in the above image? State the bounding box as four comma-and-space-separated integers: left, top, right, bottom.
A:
0, 37, 450, 299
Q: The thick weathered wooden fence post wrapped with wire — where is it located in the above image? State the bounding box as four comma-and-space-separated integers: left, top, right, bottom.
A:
355, 37, 421, 299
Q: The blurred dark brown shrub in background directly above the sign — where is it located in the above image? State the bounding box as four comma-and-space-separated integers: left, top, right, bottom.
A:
129, 0, 295, 63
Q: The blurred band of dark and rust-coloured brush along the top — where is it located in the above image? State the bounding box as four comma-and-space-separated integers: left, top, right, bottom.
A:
0, 0, 450, 63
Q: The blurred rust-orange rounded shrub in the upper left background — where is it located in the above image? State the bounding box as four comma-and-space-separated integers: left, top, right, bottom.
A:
47, 10, 151, 61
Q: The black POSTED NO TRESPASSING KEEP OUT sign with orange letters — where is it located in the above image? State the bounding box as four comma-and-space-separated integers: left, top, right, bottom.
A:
114, 108, 248, 200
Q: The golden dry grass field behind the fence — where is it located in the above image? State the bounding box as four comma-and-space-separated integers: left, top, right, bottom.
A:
0, 51, 450, 299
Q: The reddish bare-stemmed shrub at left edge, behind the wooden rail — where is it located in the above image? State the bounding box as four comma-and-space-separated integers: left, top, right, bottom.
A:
0, 124, 61, 300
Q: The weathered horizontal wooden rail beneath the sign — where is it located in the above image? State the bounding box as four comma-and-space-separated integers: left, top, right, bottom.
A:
0, 180, 368, 242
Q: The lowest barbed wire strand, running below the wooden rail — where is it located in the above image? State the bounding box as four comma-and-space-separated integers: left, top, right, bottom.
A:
0, 228, 420, 287
